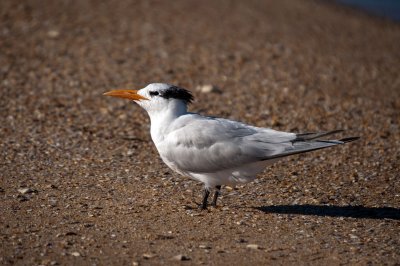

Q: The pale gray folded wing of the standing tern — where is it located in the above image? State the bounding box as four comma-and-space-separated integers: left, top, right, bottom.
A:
160, 114, 356, 173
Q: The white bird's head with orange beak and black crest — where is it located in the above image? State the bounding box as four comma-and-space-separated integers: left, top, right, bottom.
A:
104, 83, 193, 115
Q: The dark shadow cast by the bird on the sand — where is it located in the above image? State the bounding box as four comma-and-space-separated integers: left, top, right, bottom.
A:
255, 204, 400, 220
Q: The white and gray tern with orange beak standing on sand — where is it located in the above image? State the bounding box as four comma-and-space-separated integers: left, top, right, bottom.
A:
104, 83, 359, 210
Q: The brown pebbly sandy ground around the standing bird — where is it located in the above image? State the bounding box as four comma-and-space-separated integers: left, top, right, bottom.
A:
0, 0, 400, 265
